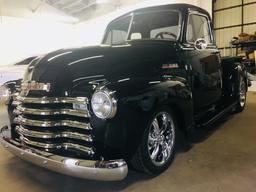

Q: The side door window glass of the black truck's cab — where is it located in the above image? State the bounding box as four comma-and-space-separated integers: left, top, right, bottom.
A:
186, 14, 213, 44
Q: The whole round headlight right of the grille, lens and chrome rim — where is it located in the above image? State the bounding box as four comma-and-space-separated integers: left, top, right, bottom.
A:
91, 90, 116, 119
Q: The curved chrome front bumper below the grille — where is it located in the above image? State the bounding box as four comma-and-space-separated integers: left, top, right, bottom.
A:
0, 126, 128, 181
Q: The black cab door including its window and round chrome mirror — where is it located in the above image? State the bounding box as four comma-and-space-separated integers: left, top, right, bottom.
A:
185, 12, 222, 111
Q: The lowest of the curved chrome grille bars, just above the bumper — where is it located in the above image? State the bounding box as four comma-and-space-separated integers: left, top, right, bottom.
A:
20, 135, 94, 155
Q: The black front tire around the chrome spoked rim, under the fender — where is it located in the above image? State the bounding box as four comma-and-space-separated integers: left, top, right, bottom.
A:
131, 107, 177, 175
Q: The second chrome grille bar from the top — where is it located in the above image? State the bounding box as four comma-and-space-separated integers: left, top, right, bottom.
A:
14, 105, 90, 117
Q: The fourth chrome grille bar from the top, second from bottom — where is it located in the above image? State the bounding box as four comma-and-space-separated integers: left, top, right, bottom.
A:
15, 126, 93, 142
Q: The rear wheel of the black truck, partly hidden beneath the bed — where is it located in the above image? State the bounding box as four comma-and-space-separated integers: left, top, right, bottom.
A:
233, 75, 247, 113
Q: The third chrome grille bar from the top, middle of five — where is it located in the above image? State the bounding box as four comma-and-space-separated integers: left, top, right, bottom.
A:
14, 116, 92, 130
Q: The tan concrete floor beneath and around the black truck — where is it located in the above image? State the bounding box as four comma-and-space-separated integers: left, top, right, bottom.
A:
0, 92, 256, 192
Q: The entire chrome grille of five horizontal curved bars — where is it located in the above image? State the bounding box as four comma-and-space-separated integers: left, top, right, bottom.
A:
13, 96, 95, 156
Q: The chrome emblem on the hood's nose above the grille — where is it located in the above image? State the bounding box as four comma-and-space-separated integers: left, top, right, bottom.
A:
21, 81, 51, 96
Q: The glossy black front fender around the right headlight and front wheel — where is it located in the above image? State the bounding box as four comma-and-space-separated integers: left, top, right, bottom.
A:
73, 77, 193, 159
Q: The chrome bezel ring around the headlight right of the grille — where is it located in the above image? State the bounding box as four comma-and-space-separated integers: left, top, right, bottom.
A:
91, 88, 117, 119
